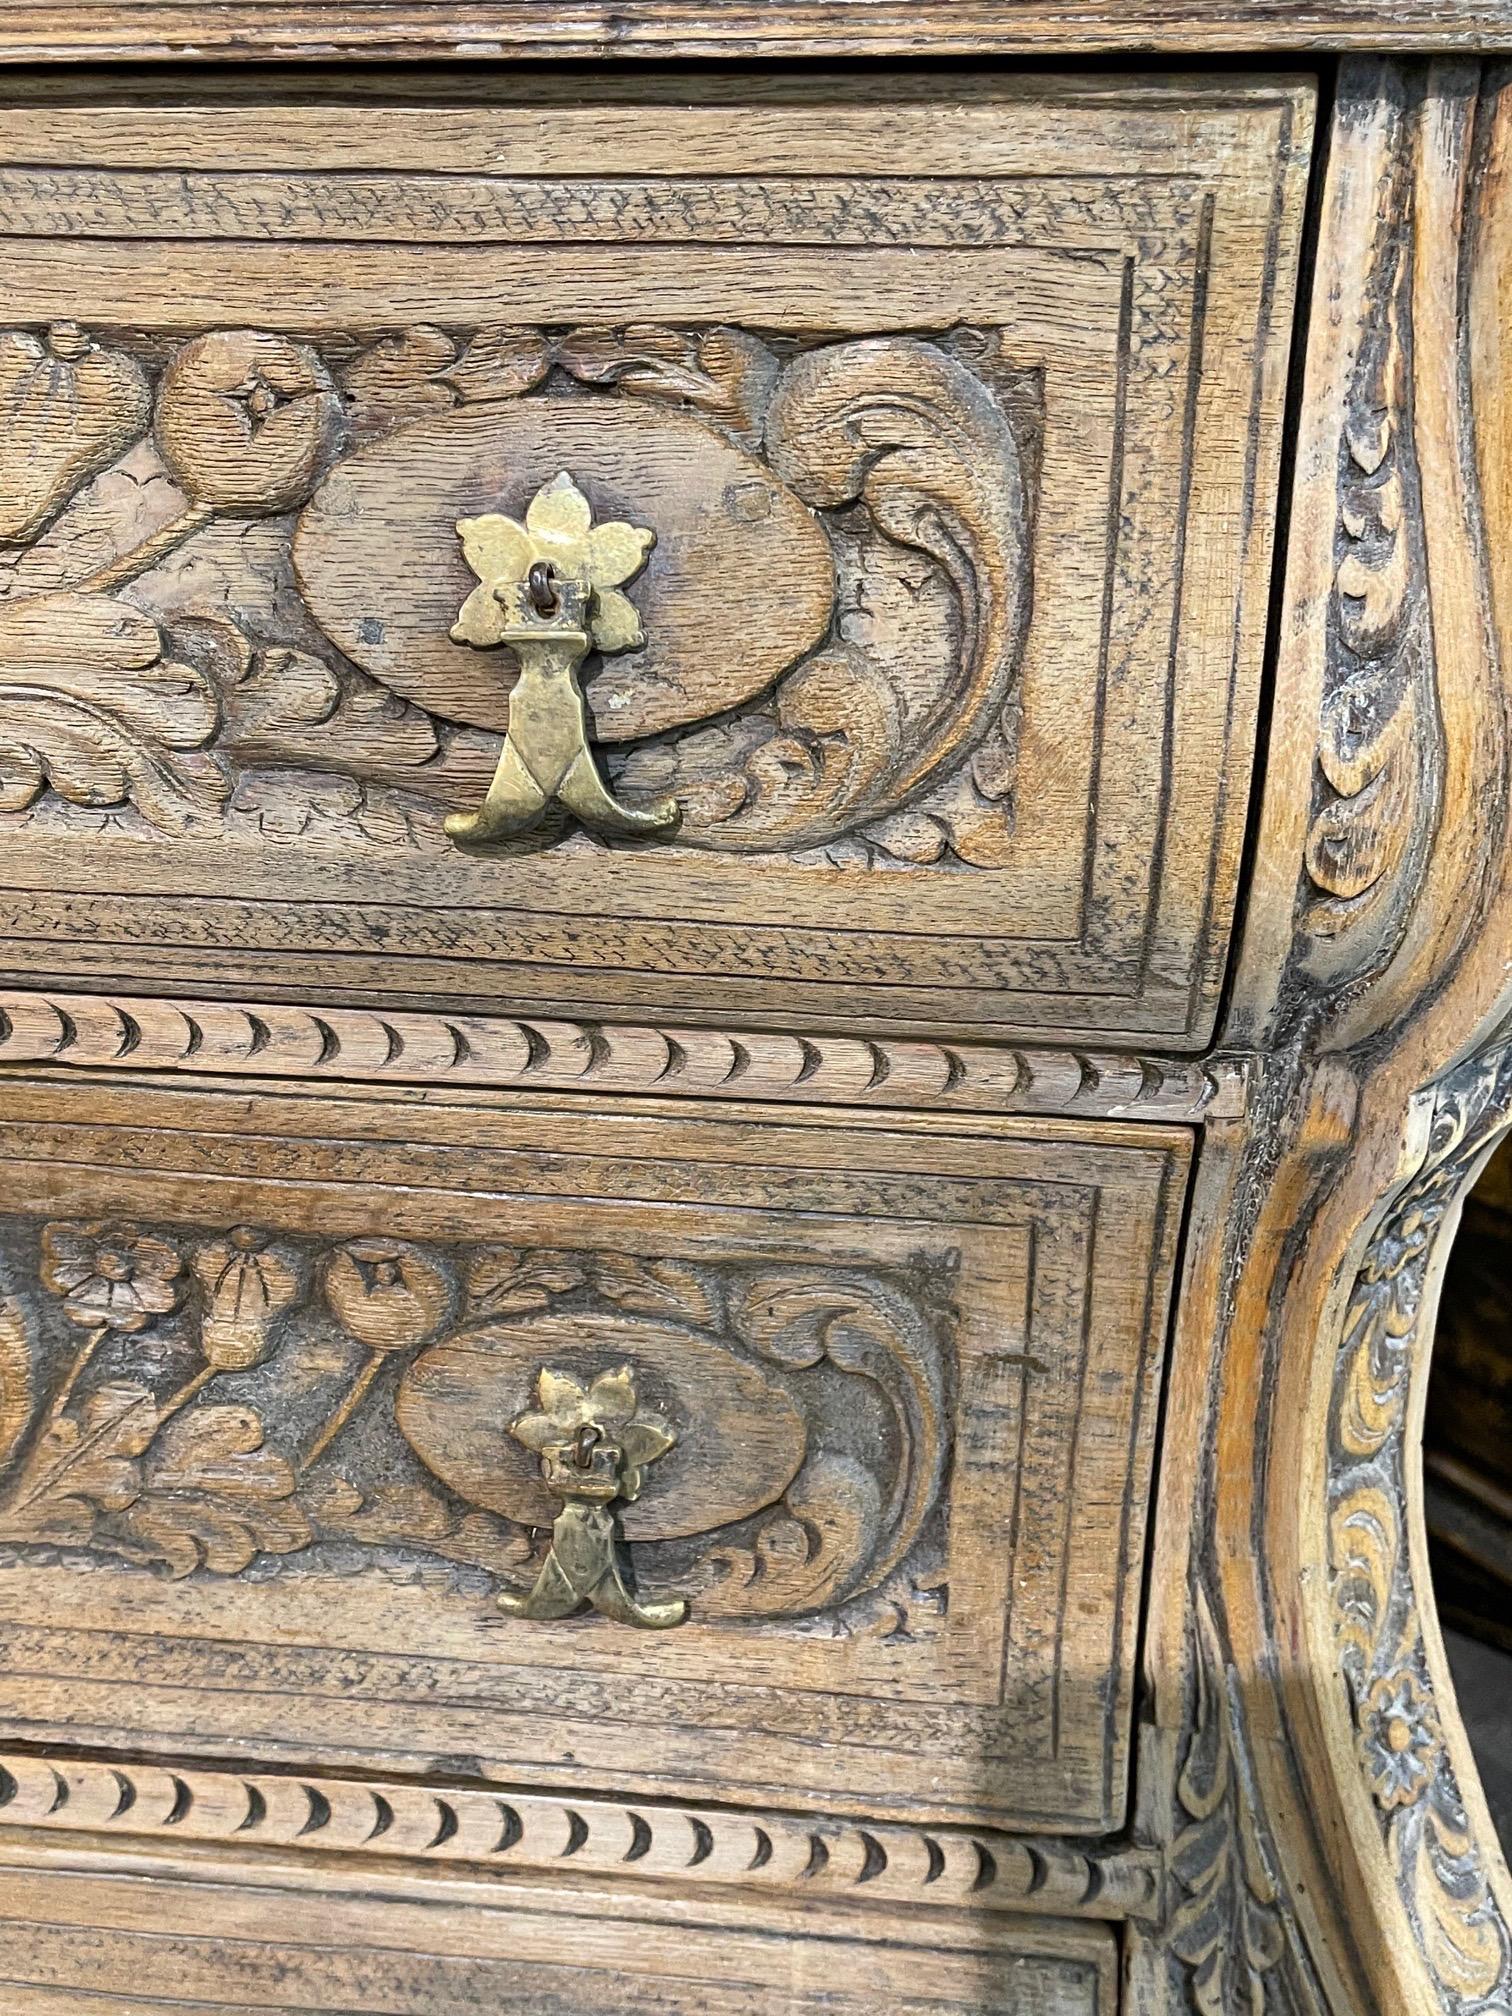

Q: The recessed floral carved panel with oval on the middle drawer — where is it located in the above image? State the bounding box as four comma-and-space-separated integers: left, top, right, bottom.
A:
0, 1222, 950, 1631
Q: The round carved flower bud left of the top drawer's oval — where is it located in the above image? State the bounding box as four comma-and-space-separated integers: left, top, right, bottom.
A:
157, 329, 341, 518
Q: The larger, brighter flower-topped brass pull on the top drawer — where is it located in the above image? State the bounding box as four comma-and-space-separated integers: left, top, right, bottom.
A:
446, 470, 679, 843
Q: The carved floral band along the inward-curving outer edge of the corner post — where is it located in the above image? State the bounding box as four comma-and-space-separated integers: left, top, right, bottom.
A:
1329, 1048, 1512, 2016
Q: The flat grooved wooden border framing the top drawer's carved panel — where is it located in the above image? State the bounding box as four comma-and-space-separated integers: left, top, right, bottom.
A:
0, 79, 1310, 1046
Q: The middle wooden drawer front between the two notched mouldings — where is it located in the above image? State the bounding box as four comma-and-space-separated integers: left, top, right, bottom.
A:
0, 1079, 1189, 1831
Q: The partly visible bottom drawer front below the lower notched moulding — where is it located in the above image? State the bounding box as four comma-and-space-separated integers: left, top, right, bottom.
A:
0, 1849, 1119, 2016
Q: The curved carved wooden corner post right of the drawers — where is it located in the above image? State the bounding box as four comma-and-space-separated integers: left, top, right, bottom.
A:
1129, 62, 1512, 2016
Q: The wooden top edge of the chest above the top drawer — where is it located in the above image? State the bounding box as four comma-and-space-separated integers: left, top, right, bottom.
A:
0, 0, 1512, 62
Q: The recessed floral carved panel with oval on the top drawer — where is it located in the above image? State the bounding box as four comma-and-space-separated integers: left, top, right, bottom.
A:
0, 325, 1030, 867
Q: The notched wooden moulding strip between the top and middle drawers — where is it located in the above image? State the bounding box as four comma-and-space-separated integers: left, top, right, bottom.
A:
0, 988, 1244, 1121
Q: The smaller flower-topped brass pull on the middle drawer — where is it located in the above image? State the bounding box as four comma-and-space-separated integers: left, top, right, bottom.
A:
498, 1365, 687, 1631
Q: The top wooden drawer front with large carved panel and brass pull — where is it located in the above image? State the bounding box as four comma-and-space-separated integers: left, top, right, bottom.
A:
0, 77, 1312, 1046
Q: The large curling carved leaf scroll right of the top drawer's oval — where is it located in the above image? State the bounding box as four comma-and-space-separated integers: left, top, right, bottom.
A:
623, 339, 1030, 867
